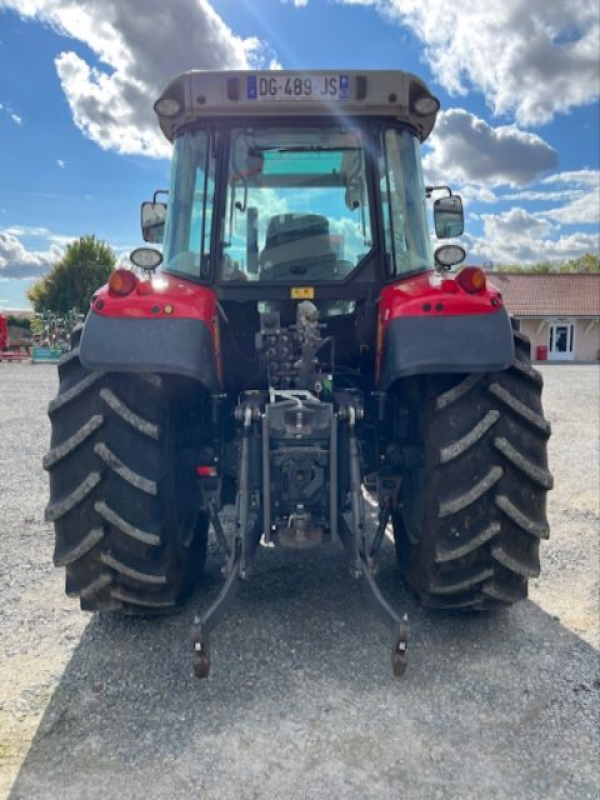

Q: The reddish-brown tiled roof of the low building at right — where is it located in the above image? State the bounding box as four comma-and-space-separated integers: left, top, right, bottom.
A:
488, 272, 600, 317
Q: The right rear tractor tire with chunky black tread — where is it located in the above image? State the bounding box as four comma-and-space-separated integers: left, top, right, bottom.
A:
394, 331, 553, 610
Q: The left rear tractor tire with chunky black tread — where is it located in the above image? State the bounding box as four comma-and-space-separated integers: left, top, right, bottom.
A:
44, 331, 208, 613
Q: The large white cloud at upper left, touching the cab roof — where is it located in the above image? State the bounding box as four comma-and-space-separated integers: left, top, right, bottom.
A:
0, 0, 273, 157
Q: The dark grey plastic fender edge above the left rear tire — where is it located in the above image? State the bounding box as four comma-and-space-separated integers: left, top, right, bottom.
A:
79, 311, 219, 392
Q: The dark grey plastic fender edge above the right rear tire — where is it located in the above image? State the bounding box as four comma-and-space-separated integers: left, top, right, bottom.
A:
379, 310, 515, 391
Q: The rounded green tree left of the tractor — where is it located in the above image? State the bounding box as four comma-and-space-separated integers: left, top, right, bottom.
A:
27, 236, 117, 315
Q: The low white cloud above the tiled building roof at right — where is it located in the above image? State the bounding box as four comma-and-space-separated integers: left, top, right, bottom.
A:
465, 207, 600, 264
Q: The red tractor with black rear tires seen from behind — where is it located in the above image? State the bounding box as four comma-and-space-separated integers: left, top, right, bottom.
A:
44, 71, 552, 677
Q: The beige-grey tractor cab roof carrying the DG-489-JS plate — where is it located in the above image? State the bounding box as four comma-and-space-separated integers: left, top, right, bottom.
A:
154, 70, 439, 142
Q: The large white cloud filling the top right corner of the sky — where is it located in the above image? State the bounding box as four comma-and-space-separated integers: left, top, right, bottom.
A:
337, 0, 600, 125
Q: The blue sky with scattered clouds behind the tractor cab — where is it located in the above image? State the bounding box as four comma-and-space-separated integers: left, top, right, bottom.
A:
0, 0, 600, 309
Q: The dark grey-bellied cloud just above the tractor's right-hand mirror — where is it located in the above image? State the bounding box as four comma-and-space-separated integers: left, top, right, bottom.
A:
423, 108, 557, 188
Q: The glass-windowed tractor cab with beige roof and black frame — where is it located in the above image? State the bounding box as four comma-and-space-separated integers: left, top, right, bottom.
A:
137, 72, 462, 388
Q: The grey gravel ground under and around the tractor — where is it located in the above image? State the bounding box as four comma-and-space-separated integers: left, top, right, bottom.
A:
0, 364, 600, 800
